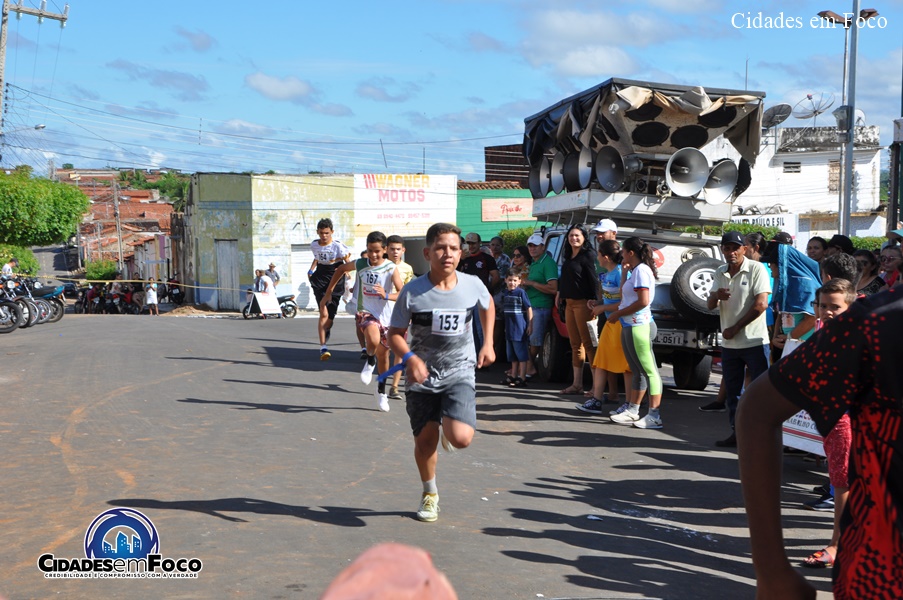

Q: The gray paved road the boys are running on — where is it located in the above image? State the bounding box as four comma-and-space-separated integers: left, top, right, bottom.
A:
0, 314, 831, 599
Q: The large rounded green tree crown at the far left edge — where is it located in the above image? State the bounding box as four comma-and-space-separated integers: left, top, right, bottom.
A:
0, 172, 89, 246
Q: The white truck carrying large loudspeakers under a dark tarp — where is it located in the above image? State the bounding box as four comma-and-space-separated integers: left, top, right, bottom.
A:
524, 79, 765, 390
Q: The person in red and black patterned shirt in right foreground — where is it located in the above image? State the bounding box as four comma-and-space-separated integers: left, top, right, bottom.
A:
737, 290, 903, 600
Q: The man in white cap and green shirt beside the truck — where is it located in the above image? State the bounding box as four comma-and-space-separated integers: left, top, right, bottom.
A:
521, 233, 558, 380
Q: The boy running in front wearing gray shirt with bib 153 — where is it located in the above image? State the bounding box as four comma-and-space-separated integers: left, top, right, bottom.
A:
389, 223, 495, 521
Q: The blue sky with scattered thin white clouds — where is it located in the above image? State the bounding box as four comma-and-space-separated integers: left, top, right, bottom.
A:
2, 0, 903, 180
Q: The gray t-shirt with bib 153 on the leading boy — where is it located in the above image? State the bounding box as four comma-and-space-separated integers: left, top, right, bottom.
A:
389, 271, 492, 392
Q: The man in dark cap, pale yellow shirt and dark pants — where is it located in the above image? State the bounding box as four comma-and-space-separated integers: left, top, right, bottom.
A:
707, 231, 771, 448
